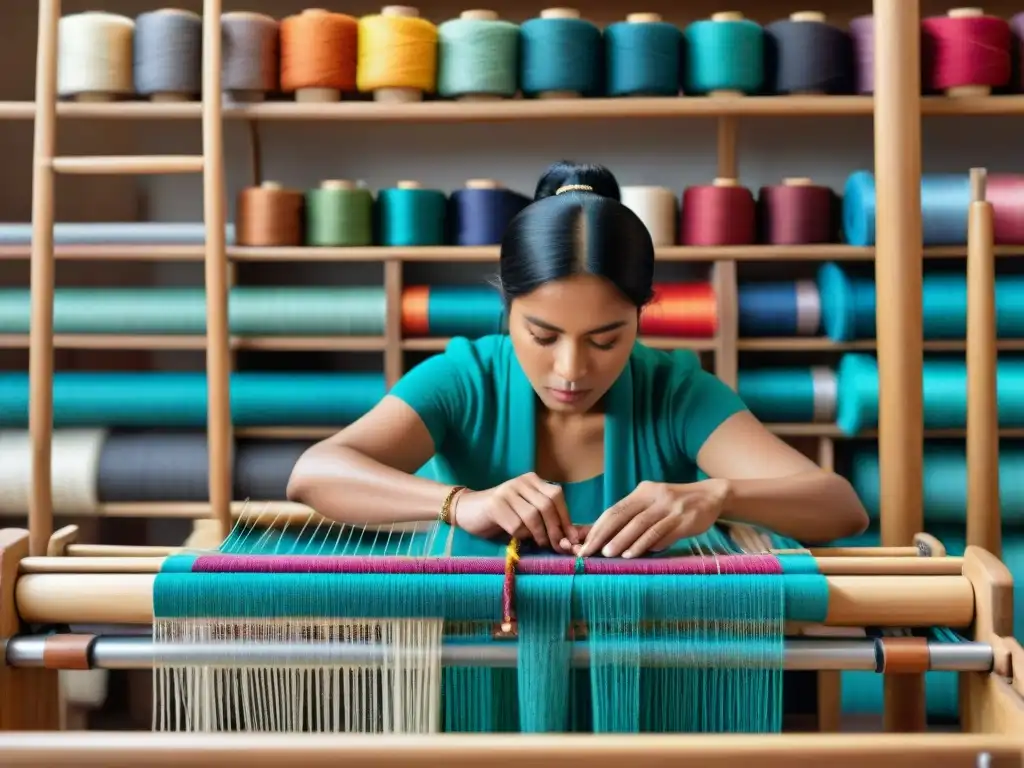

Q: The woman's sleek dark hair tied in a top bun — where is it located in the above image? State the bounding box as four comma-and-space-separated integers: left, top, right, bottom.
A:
499, 161, 654, 308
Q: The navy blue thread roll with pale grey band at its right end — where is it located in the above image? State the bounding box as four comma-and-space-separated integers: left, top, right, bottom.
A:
739, 280, 821, 338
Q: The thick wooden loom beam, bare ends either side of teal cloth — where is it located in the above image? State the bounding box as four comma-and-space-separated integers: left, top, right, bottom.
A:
15, 572, 974, 627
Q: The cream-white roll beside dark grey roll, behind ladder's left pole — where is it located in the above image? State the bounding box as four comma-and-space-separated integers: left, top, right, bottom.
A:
0, 429, 106, 515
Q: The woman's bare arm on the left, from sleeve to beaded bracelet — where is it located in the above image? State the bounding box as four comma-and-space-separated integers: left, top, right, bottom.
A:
288, 396, 452, 524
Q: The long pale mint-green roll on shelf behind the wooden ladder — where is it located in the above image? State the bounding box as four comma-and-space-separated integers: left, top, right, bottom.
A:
0, 286, 386, 336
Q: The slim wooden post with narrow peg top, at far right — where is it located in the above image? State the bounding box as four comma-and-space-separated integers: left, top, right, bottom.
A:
967, 168, 1002, 557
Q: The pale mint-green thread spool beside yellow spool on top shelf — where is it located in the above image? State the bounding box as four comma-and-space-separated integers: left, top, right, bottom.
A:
437, 10, 519, 98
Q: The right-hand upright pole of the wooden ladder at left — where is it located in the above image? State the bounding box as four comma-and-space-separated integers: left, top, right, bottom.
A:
203, 0, 233, 539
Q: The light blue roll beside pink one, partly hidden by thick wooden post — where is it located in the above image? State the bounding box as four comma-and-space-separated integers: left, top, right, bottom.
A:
843, 171, 971, 246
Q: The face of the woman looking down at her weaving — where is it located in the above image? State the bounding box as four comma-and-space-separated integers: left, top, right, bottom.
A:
509, 274, 638, 413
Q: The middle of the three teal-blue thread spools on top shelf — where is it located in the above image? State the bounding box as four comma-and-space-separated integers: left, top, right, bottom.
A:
604, 13, 683, 96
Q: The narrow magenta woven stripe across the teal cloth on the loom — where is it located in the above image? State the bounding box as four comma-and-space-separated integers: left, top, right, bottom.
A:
191, 555, 782, 575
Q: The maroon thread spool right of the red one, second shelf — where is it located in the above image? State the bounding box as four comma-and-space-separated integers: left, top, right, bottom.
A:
758, 178, 833, 246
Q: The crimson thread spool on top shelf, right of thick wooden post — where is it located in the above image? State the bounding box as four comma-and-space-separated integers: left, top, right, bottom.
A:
921, 8, 1012, 96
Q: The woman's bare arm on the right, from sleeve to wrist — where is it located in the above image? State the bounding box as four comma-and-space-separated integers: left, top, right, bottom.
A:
696, 411, 868, 544
